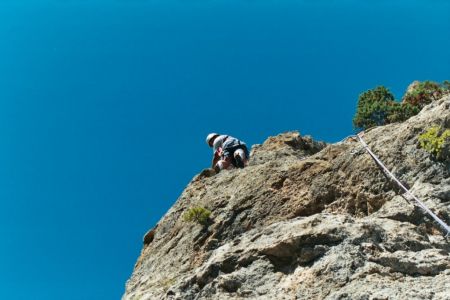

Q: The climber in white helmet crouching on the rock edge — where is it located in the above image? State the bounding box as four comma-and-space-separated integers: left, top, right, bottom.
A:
206, 133, 250, 173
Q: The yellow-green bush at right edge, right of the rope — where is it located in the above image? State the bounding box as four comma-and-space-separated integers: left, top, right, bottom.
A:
419, 126, 450, 160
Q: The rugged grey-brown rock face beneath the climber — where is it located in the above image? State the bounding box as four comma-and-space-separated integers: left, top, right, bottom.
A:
123, 96, 450, 299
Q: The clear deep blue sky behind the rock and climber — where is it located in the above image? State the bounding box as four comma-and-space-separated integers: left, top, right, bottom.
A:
0, 0, 450, 299
